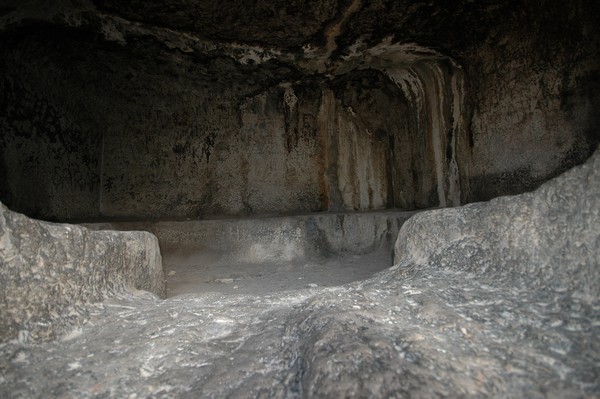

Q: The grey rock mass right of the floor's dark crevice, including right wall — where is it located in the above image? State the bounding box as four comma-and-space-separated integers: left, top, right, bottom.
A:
287, 149, 600, 397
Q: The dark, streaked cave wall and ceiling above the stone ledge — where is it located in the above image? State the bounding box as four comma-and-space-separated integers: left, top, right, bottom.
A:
0, 0, 600, 221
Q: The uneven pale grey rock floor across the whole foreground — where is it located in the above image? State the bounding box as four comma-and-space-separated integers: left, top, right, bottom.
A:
0, 254, 600, 398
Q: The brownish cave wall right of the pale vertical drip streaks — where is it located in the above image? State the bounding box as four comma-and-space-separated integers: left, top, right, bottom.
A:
456, 1, 600, 202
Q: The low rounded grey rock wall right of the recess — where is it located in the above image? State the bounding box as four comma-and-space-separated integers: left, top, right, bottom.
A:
395, 148, 600, 296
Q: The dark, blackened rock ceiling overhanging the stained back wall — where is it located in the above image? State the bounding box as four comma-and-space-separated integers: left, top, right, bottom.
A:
0, 0, 600, 84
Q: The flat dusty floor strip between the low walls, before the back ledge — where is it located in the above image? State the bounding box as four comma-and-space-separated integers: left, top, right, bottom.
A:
163, 250, 392, 297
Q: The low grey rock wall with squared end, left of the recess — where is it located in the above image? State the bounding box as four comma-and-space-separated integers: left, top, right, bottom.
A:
0, 203, 165, 342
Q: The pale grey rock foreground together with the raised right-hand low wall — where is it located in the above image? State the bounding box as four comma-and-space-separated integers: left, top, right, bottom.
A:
0, 151, 600, 398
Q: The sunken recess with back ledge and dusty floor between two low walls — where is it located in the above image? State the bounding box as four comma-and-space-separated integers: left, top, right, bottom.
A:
86, 211, 414, 296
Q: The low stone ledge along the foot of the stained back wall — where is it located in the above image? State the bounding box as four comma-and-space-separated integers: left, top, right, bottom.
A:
85, 211, 415, 266
